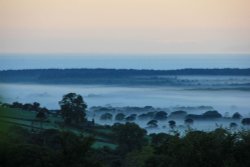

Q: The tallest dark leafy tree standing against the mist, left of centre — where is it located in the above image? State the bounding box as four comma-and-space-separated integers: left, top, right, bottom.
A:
59, 93, 87, 124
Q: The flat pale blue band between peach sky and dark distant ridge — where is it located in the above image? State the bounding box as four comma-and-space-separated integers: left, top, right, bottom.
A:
0, 54, 250, 70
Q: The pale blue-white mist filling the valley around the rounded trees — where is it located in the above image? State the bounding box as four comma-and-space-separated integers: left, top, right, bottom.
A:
0, 76, 250, 132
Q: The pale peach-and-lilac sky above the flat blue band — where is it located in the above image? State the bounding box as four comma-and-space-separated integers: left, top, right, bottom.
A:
0, 0, 250, 54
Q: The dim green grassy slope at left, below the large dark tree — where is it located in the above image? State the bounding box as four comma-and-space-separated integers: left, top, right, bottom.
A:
0, 106, 116, 148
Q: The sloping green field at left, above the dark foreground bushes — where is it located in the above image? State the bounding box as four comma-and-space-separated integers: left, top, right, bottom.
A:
0, 106, 116, 149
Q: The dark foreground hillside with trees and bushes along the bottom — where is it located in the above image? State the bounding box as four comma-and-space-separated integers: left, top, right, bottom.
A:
0, 108, 250, 167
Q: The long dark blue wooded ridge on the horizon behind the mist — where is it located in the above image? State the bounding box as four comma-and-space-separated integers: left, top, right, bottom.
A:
0, 68, 250, 85
